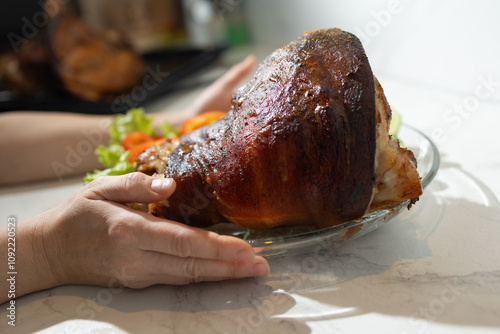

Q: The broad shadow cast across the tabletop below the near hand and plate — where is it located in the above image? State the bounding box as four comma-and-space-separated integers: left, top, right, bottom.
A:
0, 158, 500, 334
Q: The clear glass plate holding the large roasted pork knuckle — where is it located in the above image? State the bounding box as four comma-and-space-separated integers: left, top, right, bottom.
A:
210, 124, 440, 257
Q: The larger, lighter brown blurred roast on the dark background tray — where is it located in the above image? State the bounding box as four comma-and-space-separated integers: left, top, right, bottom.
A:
48, 14, 145, 101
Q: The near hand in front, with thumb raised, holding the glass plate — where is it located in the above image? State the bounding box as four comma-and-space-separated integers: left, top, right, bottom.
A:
39, 173, 269, 288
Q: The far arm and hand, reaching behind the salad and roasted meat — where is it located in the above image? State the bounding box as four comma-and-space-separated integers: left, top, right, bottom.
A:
0, 56, 255, 186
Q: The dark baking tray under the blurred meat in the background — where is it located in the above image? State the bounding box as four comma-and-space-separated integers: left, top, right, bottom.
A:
0, 47, 224, 114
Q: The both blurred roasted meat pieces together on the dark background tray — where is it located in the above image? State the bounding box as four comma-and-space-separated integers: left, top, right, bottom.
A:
0, 13, 145, 101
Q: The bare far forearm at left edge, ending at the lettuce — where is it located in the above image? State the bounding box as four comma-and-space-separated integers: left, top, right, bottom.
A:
0, 112, 111, 185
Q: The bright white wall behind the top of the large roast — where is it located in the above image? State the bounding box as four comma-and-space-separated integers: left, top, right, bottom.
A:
245, 0, 500, 102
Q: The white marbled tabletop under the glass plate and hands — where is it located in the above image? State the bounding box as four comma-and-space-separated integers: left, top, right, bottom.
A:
0, 49, 500, 334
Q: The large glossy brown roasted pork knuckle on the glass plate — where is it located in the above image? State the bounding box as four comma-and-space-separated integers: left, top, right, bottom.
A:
137, 29, 422, 229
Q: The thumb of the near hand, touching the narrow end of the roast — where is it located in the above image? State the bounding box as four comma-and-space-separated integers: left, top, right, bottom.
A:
85, 172, 175, 203
